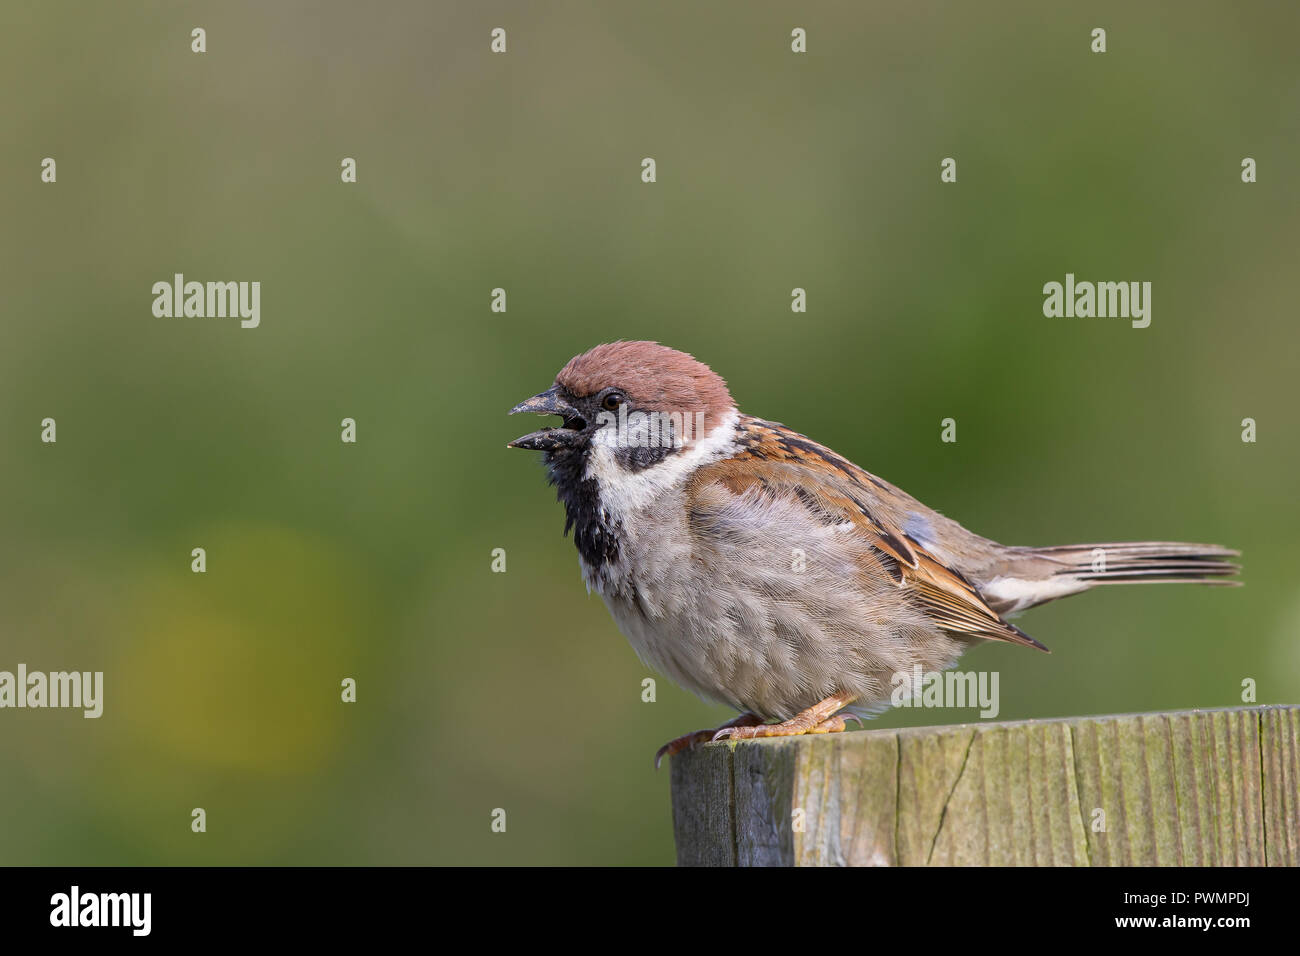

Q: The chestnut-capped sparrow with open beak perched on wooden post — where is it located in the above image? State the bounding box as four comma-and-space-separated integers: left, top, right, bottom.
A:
508, 341, 1240, 766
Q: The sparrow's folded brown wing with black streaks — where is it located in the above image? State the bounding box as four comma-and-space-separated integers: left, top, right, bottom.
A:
686, 419, 1047, 650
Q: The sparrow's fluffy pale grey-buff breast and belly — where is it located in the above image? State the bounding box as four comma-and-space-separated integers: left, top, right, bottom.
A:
582, 489, 966, 719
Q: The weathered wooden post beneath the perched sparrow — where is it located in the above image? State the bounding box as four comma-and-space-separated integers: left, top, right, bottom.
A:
672, 706, 1300, 866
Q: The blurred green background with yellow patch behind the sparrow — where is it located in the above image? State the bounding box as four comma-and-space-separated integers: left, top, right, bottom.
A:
0, 0, 1300, 864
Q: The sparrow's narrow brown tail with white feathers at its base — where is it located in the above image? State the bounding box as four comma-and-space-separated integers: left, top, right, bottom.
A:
980, 541, 1240, 613
